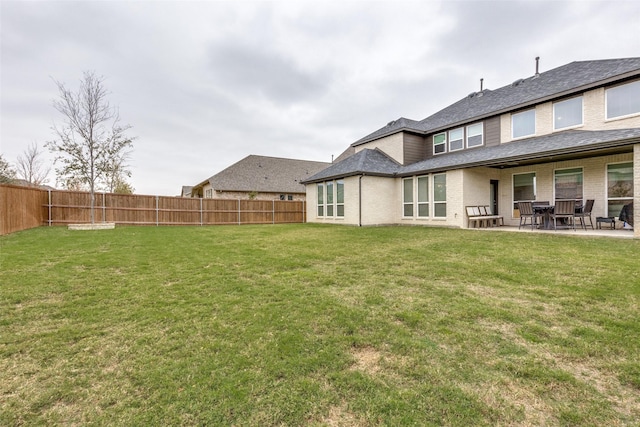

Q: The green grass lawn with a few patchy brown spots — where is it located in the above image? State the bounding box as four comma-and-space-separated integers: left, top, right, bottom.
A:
0, 224, 640, 426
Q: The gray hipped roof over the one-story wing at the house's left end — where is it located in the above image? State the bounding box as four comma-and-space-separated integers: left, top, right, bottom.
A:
303, 148, 400, 183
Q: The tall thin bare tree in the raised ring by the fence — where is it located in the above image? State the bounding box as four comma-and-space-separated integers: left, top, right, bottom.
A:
47, 71, 133, 223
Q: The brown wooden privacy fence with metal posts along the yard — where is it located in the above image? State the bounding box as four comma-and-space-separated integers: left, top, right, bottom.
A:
0, 186, 306, 234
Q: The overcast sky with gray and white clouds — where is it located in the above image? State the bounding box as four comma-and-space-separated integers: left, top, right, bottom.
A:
0, 0, 640, 196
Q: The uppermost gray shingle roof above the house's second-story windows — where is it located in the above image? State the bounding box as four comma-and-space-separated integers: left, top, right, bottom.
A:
352, 58, 640, 146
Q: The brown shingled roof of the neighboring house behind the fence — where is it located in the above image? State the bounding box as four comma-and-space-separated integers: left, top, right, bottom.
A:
194, 155, 331, 193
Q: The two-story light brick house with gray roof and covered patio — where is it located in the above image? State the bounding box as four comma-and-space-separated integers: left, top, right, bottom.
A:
305, 58, 640, 236
